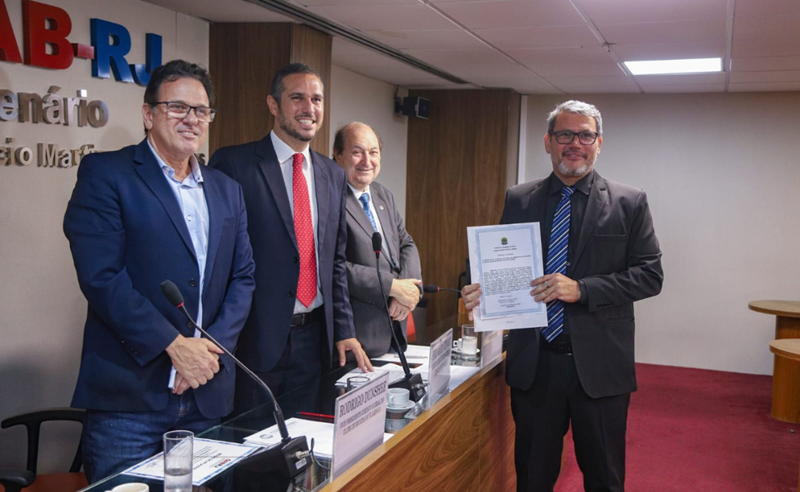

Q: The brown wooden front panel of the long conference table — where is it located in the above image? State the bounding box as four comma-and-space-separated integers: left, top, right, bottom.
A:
323, 361, 515, 492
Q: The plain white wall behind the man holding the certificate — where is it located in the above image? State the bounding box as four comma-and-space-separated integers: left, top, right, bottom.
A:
525, 92, 800, 374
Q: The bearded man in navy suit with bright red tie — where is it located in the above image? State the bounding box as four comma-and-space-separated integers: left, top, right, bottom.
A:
209, 63, 371, 413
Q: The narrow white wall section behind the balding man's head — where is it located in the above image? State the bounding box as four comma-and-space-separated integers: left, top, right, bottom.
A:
329, 65, 408, 218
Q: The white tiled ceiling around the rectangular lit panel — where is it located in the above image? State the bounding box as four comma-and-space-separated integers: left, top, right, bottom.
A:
148, 0, 800, 94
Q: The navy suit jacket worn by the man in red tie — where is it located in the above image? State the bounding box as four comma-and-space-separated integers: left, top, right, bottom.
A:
209, 134, 356, 372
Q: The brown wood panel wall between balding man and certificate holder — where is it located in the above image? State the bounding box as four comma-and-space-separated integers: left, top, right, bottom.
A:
406, 89, 520, 334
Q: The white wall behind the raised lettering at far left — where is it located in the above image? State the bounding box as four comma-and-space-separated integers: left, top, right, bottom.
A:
0, 0, 208, 472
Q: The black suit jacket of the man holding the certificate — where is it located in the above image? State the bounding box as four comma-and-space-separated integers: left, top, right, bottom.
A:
501, 171, 664, 398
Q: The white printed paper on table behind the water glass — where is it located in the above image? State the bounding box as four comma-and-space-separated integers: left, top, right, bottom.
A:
122, 437, 258, 487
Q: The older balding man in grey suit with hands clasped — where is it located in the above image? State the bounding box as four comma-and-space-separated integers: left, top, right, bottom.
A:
333, 122, 422, 357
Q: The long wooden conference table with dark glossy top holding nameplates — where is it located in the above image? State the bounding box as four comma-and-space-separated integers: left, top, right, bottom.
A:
81, 317, 516, 492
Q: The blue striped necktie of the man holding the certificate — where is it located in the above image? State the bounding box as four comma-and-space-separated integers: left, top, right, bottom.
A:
542, 186, 575, 342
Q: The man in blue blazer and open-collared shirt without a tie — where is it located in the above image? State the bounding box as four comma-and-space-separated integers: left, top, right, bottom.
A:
64, 60, 254, 482
